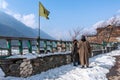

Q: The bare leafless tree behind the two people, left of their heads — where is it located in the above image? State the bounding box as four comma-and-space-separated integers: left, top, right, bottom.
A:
69, 27, 84, 40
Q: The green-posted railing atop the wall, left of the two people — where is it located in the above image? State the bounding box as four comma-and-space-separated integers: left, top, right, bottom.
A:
0, 36, 72, 55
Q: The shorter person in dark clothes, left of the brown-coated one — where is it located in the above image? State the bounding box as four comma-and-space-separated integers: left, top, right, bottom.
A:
71, 39, 80, 66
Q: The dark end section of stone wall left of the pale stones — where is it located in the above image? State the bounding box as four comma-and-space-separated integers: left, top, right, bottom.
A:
0, 58, 23, 76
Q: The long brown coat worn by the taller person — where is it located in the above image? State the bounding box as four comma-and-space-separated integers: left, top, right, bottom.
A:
78, 41, 91, 66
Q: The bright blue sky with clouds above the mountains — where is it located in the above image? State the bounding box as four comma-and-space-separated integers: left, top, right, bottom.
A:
0, 0, 120, 39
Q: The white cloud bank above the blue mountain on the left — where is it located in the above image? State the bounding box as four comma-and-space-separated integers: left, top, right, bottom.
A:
0, 0, 37, 28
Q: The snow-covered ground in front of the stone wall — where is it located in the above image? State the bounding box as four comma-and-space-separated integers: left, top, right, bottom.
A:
0, 50, 120, 80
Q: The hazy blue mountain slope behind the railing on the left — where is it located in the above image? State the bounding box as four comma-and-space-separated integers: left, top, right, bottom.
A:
0, 11, 54, 39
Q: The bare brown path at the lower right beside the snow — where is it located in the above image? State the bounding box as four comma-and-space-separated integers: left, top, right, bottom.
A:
107, 56, 120, 80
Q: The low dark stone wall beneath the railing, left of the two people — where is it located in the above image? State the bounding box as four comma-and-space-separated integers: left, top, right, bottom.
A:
0, 54, 71, 77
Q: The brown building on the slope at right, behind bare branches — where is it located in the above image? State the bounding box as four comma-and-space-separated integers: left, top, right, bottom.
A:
88, 25, 120, 43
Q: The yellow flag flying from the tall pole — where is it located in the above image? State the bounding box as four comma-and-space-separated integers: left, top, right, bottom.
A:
39, 2, 50, 19
